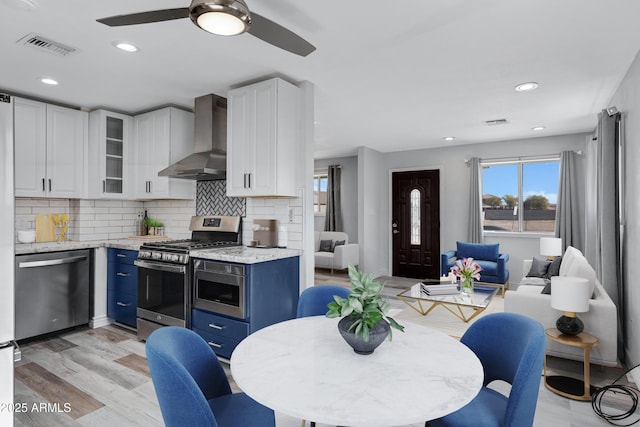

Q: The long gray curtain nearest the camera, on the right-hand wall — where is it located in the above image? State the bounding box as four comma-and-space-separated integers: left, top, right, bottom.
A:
587, 110, 626, 360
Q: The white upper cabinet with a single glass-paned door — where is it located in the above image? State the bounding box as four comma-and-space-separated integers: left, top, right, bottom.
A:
87, 110, 132, 199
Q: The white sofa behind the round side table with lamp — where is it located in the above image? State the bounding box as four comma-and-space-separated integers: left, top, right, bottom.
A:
504, 246, 618, 366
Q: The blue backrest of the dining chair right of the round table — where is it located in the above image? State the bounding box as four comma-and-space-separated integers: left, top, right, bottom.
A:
460, 313, 546, 427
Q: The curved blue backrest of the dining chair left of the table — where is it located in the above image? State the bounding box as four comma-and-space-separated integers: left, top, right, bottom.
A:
146, 326, 231, 427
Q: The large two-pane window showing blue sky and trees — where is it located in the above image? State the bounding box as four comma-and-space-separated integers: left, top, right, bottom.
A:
482, 158, 560, 233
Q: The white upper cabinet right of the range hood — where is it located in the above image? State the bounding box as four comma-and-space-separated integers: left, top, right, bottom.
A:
227, 78, 299, 197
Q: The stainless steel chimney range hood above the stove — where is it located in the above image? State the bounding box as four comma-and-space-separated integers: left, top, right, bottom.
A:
158, 95, 227, 181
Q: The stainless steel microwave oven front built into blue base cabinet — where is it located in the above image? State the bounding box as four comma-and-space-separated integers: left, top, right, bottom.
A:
193, 260, 245, 319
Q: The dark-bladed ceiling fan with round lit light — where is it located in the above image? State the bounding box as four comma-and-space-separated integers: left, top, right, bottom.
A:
97, 0, 316, 56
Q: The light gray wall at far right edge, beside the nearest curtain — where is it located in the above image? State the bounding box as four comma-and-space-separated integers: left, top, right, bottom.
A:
602, 48, 640, 383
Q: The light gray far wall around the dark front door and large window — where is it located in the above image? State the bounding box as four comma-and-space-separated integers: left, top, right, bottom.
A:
358, 134, 587, 282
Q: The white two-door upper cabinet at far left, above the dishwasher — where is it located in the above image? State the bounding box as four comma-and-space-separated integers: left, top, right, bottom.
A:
14, 98, 87, 198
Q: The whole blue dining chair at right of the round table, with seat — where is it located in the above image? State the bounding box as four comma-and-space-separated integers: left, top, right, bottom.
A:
425, 313, 546, 427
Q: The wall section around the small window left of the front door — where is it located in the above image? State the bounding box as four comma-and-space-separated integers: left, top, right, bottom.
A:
314, 156, 358, 243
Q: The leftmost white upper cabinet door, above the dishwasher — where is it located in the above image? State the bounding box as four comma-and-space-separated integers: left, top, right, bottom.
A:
14, 98, 47, 197
